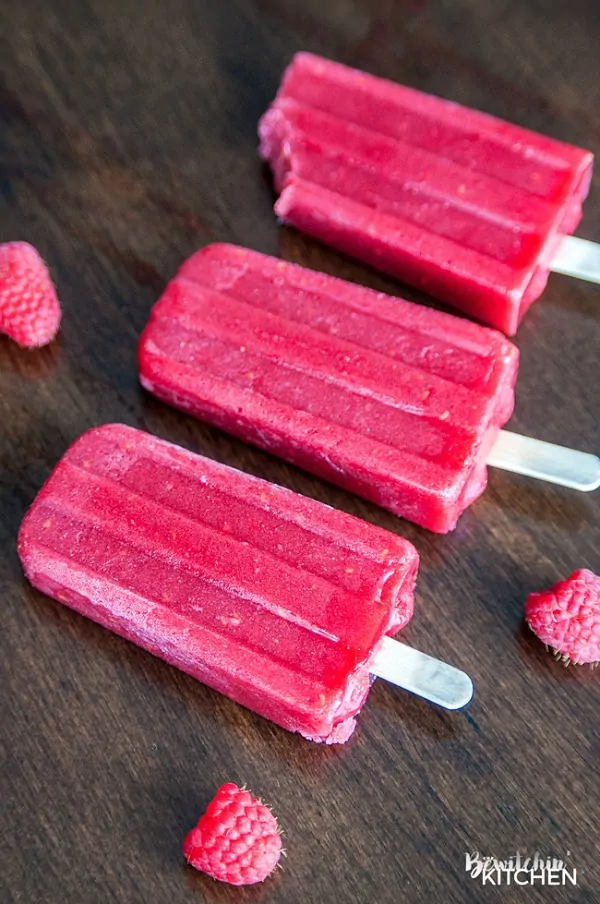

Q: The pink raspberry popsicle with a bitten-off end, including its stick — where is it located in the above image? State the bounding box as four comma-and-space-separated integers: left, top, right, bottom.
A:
259, 53, 600, 335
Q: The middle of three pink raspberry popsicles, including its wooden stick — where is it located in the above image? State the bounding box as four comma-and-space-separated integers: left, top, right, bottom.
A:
139, 245, 600, 533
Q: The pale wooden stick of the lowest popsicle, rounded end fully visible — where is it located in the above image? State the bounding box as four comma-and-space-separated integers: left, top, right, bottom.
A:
371, 637, 473, 709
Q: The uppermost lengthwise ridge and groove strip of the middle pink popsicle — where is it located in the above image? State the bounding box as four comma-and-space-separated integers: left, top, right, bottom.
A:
175, 244, 516, 378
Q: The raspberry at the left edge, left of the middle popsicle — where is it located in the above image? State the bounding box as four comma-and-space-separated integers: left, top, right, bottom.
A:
0, 242, 61, 348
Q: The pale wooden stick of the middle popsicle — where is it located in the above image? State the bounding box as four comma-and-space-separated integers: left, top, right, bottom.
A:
487, 430, 600, 493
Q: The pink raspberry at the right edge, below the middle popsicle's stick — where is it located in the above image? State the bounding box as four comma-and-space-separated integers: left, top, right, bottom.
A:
525, 568, 600, 665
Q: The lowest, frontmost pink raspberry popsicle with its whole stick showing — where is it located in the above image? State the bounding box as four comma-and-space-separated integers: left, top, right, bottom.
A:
19, 424, 472, 743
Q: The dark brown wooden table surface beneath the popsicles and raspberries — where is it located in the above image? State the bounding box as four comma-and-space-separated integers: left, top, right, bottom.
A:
0, 0, 600, 904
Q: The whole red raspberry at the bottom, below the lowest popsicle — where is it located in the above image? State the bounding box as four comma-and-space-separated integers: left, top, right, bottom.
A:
183, 783, 281, 885
